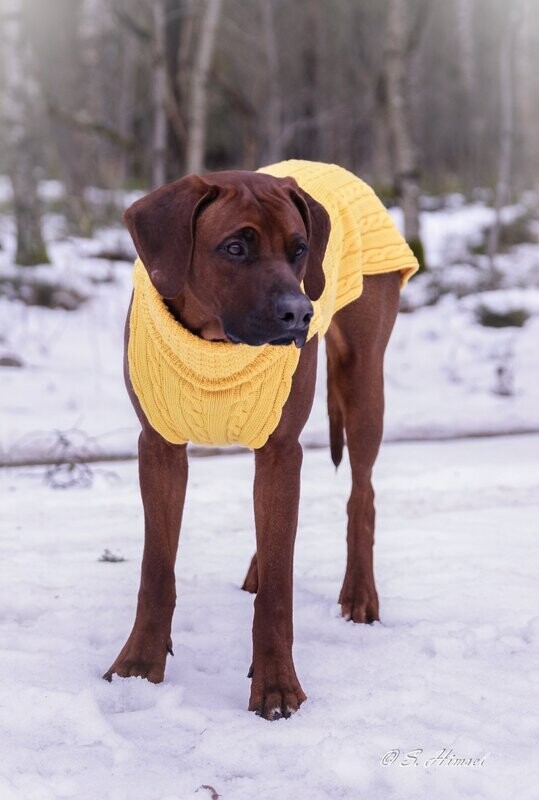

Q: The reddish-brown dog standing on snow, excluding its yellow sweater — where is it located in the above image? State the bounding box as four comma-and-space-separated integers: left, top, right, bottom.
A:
104, 162, 414, 719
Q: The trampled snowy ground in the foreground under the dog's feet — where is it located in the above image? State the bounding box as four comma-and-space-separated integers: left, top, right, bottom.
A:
0, 435, 539, 800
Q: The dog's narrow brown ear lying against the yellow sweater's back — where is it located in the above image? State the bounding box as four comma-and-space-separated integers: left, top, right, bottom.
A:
292, 186, 331, 300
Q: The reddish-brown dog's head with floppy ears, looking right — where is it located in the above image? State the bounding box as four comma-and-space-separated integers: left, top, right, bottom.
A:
125, 171, 330, 347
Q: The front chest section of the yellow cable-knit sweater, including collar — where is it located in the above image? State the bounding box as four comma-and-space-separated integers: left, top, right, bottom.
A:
128, 262, 300, 449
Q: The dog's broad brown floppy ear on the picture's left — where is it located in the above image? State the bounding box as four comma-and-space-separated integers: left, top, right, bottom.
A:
124, 175, 218, 299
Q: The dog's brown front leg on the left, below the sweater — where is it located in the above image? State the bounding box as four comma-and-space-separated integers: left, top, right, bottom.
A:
103, 428, 187, 683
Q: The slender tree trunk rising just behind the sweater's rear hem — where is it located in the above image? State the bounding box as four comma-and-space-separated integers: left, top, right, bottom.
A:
385, 0, 424, 266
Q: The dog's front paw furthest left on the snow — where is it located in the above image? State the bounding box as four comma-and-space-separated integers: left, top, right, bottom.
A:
103, 631, 174, 683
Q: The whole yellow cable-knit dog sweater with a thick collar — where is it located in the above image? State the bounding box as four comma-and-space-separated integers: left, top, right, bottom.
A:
128, 161, 418, 449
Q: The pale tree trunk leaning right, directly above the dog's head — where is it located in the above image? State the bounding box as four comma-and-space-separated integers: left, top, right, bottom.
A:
186, 0, 222, 173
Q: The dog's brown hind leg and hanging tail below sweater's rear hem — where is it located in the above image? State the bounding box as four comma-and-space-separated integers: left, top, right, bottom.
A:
326, 272, 399, 623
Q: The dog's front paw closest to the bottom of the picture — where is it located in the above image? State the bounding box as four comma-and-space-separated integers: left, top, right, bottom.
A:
249, 660, 307, 721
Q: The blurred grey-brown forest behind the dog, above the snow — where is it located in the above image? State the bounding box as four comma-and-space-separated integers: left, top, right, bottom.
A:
0, 0, 539, 264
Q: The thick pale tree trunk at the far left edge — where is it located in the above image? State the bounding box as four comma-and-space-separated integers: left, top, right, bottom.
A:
2, 0, 49, 266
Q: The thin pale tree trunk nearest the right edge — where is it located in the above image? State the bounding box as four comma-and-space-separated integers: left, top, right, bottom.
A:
487, 0, 523, 286
